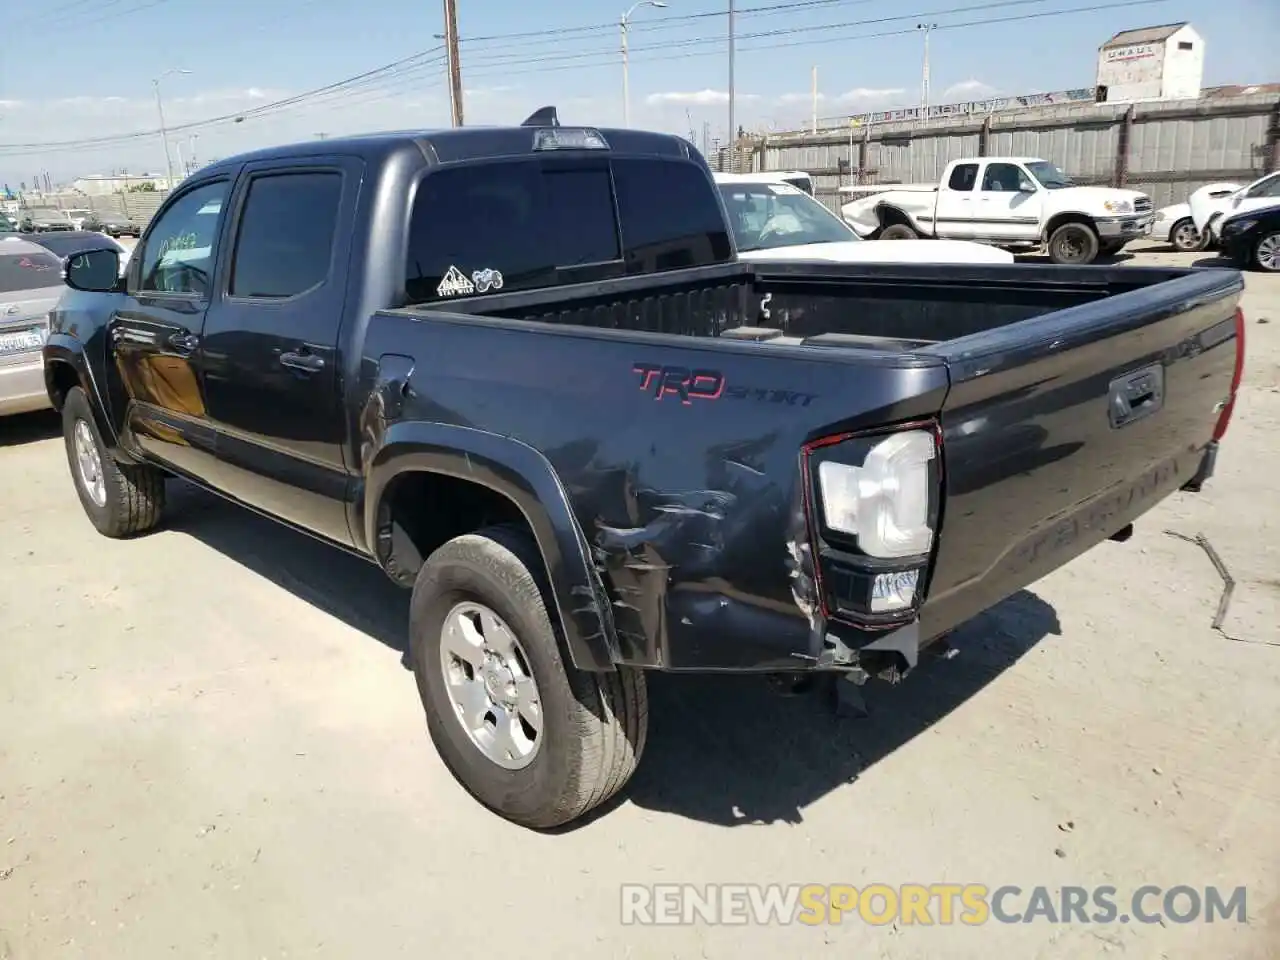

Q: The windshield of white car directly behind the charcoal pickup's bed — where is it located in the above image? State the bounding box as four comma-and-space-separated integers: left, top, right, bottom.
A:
719, 183, 859, 251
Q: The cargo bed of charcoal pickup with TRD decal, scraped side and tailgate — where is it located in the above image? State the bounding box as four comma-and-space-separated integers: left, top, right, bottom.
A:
376, 264, 1243, 669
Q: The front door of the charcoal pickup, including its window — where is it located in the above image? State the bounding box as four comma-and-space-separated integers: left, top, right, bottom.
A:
108, 179, 230, 477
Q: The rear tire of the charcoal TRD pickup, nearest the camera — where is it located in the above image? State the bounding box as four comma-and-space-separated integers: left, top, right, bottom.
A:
410, 526, 649, 829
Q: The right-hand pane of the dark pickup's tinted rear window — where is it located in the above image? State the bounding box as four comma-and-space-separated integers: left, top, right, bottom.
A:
613, 159, 732, 274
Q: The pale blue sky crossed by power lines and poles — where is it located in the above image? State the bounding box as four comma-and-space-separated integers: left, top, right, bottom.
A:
0, 0, 1280, 187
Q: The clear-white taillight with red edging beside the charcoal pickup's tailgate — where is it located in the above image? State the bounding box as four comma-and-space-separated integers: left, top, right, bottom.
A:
801, 422, 942, 626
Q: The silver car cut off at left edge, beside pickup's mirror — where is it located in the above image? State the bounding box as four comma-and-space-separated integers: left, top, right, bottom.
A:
0, 237, 67, 416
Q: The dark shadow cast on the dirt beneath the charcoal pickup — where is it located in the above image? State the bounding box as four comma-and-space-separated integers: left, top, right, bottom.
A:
166, 481, 1061, 827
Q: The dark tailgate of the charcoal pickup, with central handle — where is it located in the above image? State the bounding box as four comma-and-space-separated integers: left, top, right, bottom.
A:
922, 270, 1244, 636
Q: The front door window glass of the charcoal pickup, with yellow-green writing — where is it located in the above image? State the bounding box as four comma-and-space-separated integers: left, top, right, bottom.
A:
140, 180, 228, 296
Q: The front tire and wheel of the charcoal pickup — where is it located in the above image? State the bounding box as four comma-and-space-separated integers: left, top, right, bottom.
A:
63, 387, 165, 538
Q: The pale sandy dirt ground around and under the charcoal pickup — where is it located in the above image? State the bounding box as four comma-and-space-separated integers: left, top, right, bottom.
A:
0, 241, 1280, 960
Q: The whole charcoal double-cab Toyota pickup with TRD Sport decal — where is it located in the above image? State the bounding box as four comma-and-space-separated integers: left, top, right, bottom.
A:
44, 110, 1243, 828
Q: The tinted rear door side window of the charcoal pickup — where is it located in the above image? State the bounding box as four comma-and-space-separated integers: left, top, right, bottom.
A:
229, 172, 342, 300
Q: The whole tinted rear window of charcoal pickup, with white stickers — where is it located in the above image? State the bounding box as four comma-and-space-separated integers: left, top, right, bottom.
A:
404, 157, 732, 303
